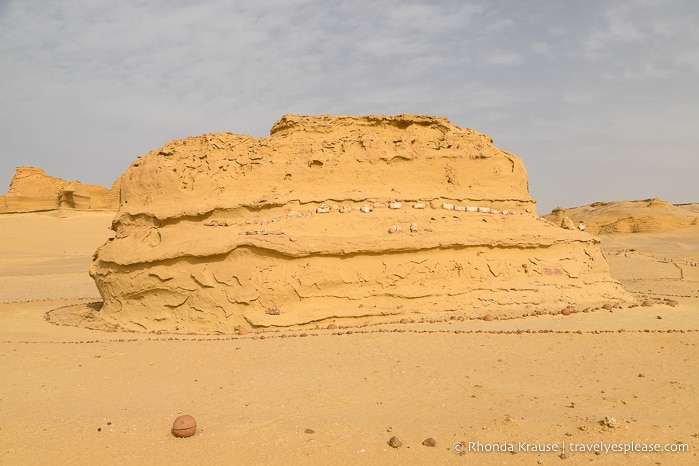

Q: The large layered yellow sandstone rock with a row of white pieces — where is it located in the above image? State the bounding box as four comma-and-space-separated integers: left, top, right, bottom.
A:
90, 115, 628, 333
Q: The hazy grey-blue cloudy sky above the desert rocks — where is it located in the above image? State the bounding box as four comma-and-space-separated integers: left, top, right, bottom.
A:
0, 0, 699, 213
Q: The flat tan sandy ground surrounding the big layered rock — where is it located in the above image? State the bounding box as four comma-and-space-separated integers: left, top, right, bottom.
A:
0, 212, 699, 465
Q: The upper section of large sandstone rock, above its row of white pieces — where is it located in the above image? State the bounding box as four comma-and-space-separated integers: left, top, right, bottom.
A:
120, 115, 534, 219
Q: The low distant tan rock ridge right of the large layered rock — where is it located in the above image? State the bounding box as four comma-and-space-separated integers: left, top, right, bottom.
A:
544, 198, 699, 235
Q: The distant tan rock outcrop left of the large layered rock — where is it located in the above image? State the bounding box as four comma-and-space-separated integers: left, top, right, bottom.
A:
0, 167, 120, 213
